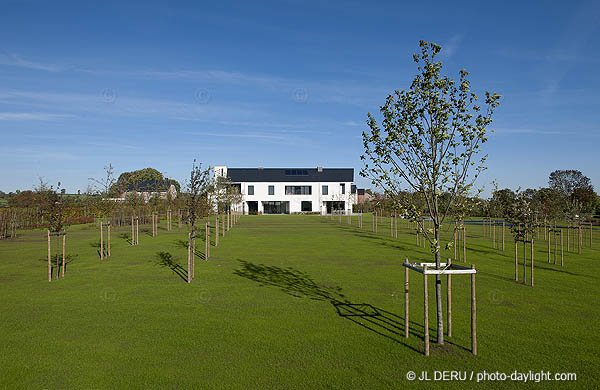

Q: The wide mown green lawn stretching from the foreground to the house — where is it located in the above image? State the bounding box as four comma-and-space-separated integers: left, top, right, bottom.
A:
0, 215, 600, 389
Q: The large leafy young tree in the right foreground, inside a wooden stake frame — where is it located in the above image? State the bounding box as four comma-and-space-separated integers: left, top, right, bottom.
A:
361, 41, 500, 344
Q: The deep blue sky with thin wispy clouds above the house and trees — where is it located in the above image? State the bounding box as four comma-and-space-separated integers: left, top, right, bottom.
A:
0, 1, 600, 192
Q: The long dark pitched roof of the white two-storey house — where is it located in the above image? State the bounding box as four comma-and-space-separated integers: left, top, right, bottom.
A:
227, 168, 354, 183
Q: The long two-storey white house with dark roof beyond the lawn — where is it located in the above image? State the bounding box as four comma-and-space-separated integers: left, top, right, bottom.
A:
214, 165, 356, 215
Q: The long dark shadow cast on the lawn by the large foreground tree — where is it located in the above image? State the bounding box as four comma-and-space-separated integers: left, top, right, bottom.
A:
234, 260, 424, 353
